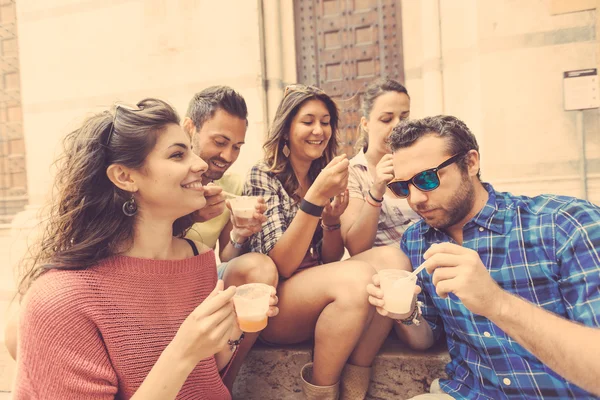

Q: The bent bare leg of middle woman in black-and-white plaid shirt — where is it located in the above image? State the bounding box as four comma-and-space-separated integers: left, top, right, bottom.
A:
262, 260, 375, 386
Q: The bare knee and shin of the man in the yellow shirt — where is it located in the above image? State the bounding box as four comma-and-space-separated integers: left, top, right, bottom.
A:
223, 253, 278, 392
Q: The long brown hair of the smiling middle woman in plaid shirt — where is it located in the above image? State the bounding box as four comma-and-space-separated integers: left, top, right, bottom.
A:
263, 85, 339, 201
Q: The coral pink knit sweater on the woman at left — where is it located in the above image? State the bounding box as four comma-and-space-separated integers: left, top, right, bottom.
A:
14, 250, 231, 400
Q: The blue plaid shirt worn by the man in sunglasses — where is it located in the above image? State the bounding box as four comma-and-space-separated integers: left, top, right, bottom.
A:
401, 184, 600, 400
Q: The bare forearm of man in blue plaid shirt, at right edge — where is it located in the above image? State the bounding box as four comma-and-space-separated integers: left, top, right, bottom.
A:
488, 292, 600, 396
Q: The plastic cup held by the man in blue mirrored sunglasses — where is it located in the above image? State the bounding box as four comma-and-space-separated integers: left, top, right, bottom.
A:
377, 269, 417, 318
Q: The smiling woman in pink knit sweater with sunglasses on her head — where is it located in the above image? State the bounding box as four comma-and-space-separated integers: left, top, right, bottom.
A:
14, 99, 276, 400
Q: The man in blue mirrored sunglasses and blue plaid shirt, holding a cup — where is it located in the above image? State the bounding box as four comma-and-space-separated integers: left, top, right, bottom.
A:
367, 116, 600, 400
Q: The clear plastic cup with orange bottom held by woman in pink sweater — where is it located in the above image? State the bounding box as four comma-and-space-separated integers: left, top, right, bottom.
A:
233, 283, 273, 332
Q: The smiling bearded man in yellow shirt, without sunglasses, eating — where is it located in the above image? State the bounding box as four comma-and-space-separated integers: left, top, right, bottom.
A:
183, 86, 278, 391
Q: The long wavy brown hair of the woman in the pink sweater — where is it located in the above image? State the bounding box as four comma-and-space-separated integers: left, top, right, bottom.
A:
19, 99, 192, 294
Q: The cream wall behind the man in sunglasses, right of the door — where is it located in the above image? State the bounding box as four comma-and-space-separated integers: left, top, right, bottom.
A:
402, 0, 600, 204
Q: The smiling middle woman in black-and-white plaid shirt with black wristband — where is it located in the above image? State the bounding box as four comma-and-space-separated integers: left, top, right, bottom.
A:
244, 85, 410, 399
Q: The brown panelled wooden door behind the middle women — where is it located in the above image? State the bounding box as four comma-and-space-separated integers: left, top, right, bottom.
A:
294, 0, 404, 156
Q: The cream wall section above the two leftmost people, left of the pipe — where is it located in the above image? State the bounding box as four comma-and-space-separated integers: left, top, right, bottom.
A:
17, 0, 264, 204
